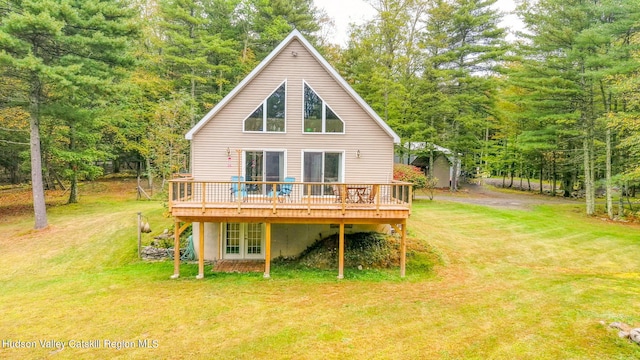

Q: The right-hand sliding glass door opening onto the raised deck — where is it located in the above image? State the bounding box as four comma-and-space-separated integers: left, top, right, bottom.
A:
303, 151, 342, 195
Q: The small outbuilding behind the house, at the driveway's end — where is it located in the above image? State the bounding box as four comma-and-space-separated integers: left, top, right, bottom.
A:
396, 142, 461, 188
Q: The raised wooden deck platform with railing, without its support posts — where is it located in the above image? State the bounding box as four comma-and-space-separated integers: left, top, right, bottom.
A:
169, 180, 412, 224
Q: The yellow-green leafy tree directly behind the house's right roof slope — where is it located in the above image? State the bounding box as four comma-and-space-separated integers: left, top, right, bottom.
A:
337, 0, 428, 166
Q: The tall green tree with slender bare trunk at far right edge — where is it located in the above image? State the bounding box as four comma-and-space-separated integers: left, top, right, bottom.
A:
521, 0, 640, 215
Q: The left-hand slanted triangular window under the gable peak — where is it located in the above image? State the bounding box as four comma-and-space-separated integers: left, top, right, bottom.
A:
244, 82, 286, 132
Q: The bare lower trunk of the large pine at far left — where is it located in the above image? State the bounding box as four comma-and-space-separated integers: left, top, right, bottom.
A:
29, 79, 48, 230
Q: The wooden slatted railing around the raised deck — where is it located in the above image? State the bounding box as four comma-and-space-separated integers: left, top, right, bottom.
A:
169, 179, 412, 210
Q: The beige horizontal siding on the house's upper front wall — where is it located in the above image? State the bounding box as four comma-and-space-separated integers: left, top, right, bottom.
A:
192, 38, 393, 183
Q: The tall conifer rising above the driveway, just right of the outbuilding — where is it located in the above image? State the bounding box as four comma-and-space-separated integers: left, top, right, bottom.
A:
423, 0, 507, 191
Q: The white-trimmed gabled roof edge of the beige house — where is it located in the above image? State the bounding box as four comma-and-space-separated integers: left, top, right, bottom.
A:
185, 30, 400, 144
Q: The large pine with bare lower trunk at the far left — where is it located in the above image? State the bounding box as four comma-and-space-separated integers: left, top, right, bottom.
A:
0, 0, 135, 225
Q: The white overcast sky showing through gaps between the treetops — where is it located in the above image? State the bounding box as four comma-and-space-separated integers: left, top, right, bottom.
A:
314, 0, 522, 46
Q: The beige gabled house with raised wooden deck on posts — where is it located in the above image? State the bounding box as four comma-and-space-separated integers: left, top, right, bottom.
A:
169, 30, 411, 278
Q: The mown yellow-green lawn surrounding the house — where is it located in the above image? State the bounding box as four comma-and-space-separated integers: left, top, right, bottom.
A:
0, 183, 640, 359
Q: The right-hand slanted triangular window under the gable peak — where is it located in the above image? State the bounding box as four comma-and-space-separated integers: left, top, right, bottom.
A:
304, 82, 344, 133
